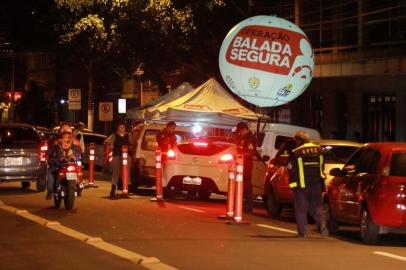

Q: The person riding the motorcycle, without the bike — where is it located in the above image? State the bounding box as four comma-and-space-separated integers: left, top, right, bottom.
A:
46, 132, 81, 200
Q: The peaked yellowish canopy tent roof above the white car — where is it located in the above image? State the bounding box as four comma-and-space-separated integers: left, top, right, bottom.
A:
145, 78, 266, 126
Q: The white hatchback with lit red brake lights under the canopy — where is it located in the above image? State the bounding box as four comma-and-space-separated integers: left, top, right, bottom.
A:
163, 137, 266, 200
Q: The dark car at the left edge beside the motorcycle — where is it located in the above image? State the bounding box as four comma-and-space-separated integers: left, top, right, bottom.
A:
0, 123, 47, 192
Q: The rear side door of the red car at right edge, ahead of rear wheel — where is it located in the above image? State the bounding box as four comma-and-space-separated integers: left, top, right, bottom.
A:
339, 148, 381, 223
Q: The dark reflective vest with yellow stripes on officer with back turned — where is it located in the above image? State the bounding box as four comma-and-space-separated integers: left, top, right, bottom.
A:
289, 143, 325, 188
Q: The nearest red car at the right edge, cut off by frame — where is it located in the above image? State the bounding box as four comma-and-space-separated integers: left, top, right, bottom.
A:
324, 142, 406, 243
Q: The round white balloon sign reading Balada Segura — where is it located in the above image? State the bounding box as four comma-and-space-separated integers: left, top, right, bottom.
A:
219, 16, 314, 107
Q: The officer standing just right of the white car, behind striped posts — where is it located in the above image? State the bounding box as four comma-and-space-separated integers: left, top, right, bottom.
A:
236, 122, 256, 212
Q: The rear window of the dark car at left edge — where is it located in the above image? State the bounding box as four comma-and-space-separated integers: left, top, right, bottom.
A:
0, 127, 40, 147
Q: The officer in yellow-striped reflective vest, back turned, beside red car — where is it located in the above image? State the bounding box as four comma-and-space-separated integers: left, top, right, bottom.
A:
289, 131, 328, 238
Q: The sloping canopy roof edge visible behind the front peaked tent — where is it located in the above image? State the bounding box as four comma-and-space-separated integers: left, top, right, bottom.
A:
127, 82, 193, 120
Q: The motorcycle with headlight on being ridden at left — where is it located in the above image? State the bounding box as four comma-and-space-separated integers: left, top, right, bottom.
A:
54, 161, 78, 210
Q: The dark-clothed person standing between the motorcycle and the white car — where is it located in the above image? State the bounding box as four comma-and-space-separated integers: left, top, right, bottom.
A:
105, 123, 132, 198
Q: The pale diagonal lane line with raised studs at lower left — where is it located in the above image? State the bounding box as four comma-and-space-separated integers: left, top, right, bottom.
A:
0, 201, 177, 270
